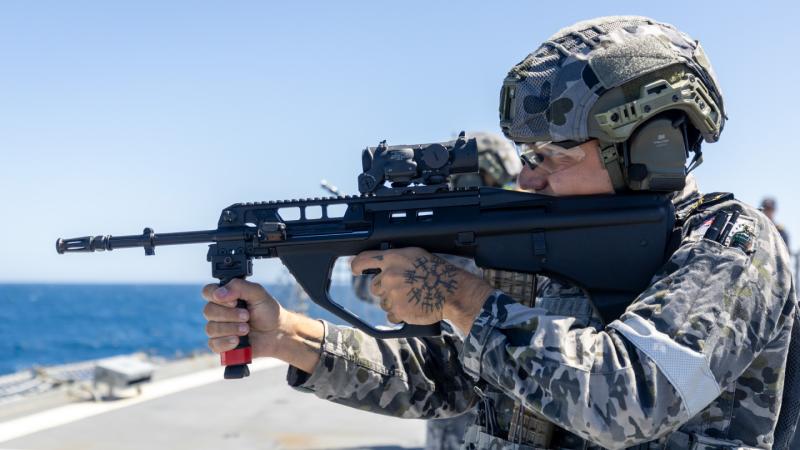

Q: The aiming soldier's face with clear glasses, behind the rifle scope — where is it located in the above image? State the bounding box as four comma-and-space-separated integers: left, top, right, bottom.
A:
517, 140, 614, 196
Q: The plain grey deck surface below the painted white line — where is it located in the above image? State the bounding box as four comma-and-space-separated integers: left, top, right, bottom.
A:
0, 367, 425, 450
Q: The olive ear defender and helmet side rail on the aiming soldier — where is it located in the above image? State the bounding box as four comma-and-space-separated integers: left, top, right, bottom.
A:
590, 68, 722, 191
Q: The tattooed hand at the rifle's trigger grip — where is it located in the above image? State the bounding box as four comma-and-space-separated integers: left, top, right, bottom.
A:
351, 247, 491, 325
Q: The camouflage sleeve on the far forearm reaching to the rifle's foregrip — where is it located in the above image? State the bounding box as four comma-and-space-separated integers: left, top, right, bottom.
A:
287, 321, 475, 418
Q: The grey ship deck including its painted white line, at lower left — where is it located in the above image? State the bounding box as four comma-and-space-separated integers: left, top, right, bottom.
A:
0, 355, 425, 450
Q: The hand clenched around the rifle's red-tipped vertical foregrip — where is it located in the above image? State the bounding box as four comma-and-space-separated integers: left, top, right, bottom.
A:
203, 279, 287, 357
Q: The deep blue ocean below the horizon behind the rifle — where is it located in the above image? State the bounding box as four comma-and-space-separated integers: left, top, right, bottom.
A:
0, 284, 384, 375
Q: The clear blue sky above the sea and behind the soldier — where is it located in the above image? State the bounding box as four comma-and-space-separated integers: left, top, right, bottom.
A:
0, 1, 800, 282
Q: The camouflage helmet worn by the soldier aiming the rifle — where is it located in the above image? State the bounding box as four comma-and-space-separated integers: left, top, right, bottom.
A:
500, 16, 726, 187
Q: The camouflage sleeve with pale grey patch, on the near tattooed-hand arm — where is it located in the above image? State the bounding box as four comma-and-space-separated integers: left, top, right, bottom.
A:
462, 206, 796, 449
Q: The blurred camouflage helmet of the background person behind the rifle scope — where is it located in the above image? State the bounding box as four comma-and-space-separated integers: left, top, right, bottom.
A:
451, 131, 522, 187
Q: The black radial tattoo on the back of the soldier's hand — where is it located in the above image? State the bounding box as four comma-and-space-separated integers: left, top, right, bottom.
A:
404, 256, 458, 314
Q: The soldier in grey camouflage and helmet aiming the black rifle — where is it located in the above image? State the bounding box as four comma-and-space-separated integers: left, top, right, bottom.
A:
203, 16, 800, 450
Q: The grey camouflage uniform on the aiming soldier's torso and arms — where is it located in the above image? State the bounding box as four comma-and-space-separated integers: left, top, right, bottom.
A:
288, 178, 797, 448
